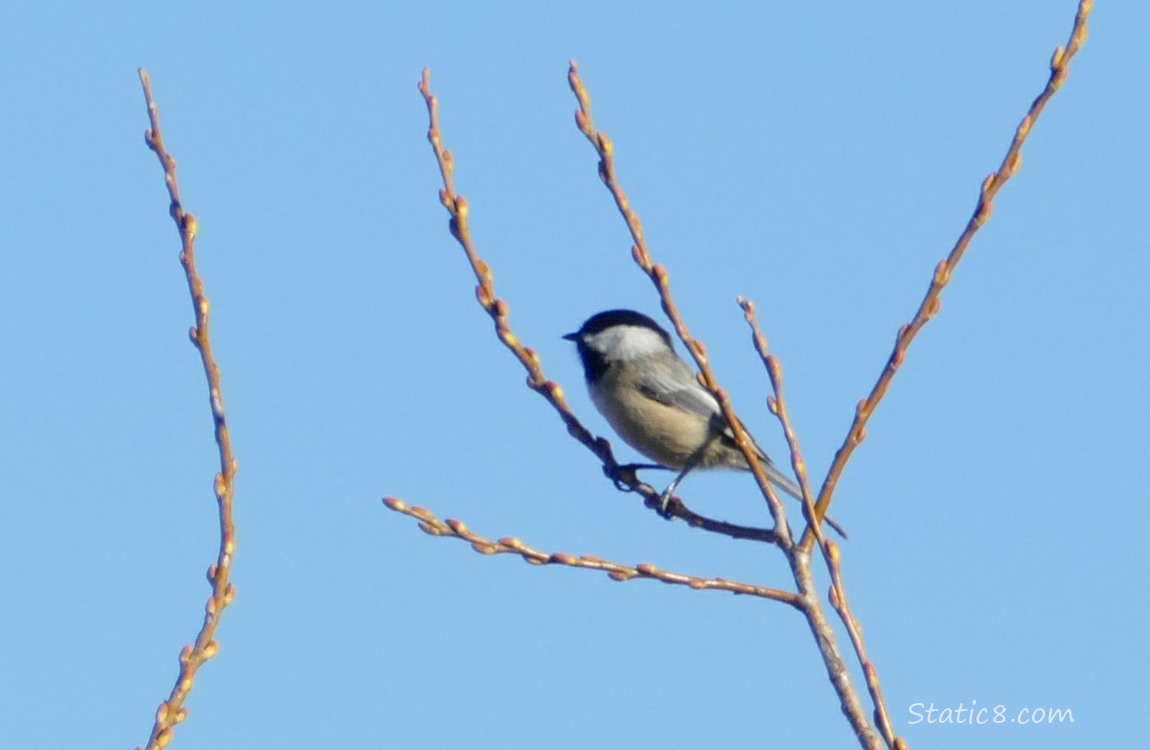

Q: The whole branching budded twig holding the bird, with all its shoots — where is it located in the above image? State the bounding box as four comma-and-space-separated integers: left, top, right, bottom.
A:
409, 0, 1091, 748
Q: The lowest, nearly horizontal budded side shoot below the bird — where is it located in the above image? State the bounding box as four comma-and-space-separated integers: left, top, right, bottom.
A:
383, 497, 799, 607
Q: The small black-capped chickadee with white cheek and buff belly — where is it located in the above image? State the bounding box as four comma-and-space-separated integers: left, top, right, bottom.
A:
564, 309, 846, 533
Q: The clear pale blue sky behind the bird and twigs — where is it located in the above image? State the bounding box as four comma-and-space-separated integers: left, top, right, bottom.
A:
0, 0, 1150, 748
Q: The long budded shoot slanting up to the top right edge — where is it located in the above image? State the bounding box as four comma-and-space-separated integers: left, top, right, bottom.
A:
800, 0, 1094, 549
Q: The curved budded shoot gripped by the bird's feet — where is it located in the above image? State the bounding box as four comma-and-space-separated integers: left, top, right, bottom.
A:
419, 68, 777, 544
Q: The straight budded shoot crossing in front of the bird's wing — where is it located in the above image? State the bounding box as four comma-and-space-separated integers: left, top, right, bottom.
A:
567, 60, 791, 548
